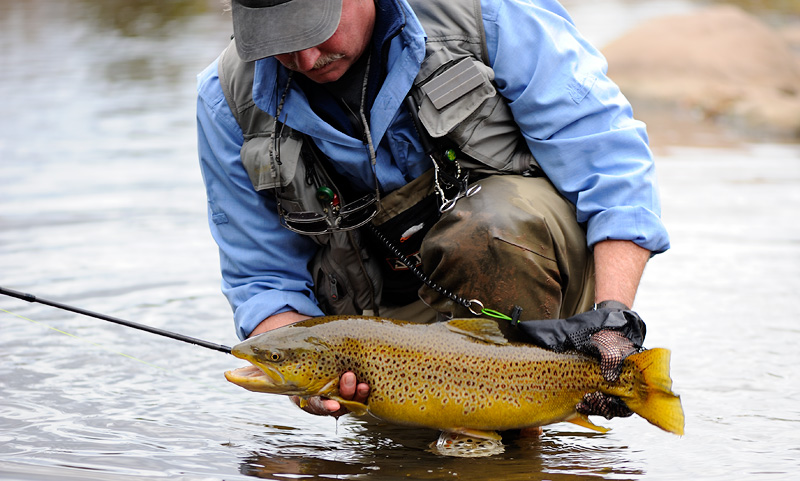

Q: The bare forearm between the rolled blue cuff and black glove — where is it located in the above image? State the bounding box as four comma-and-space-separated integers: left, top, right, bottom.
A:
594, 240, 650, 307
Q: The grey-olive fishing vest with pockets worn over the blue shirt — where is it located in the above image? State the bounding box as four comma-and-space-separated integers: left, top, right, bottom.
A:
218, 0, 538, 314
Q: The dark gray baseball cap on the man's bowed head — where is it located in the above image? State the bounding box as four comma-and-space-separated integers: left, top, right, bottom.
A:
231, 0, 342, 62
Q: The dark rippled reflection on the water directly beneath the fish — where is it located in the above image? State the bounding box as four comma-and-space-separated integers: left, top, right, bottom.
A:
239, 418, 645, 481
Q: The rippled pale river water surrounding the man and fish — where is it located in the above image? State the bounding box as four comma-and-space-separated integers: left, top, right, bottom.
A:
0, 0, 800, 481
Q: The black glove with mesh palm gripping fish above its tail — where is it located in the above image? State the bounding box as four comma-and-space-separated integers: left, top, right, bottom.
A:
517, 301, 646, 382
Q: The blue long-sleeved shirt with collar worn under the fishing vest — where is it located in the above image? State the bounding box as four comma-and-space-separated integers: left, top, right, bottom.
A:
197, 0, 669, 339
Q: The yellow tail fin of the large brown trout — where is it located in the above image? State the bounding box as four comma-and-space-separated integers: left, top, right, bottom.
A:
623, 348, 684, 436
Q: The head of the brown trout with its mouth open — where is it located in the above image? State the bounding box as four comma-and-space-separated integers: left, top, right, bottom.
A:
225, 326, 341, 397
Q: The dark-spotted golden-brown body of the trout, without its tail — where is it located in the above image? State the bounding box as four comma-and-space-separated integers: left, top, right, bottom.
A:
248, 317, 608, 430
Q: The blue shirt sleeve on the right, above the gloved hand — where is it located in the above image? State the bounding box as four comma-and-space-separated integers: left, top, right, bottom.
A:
482, 0, 669, 253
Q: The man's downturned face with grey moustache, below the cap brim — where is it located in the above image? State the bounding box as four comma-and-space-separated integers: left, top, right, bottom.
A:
275, 0, 375, 83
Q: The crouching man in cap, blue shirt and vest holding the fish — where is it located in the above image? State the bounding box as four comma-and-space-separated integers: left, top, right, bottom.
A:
198, 0, 669, 415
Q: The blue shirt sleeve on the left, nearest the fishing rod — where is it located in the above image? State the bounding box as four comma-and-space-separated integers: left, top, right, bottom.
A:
197, 59, 322, 339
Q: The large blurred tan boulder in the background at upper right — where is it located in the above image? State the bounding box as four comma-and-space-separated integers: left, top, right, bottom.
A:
604, 5, 800, 140
